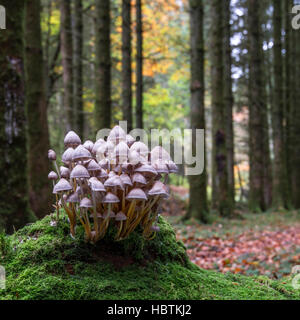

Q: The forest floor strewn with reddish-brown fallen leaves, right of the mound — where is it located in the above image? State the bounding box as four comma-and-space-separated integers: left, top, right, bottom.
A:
163, 187, 300, 279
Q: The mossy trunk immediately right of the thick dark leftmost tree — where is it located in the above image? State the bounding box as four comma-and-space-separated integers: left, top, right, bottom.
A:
24, 0, 52, 218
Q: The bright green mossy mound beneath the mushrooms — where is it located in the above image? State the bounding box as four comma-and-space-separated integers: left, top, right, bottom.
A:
0, 216, 300, 300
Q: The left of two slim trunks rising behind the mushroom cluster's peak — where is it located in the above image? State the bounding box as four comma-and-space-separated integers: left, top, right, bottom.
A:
122, 0, 132, 131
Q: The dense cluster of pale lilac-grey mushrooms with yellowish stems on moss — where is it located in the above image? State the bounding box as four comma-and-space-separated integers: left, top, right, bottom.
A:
48, 126, 177, 243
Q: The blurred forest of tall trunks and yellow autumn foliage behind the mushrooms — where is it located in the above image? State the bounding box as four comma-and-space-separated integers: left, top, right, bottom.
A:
0, 0, 300, 276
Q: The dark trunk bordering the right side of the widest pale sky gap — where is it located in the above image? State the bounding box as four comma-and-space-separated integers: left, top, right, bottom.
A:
248, 0, 270, 212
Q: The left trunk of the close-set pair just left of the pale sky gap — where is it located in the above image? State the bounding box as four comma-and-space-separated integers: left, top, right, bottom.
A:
211, 0, 232, 216
